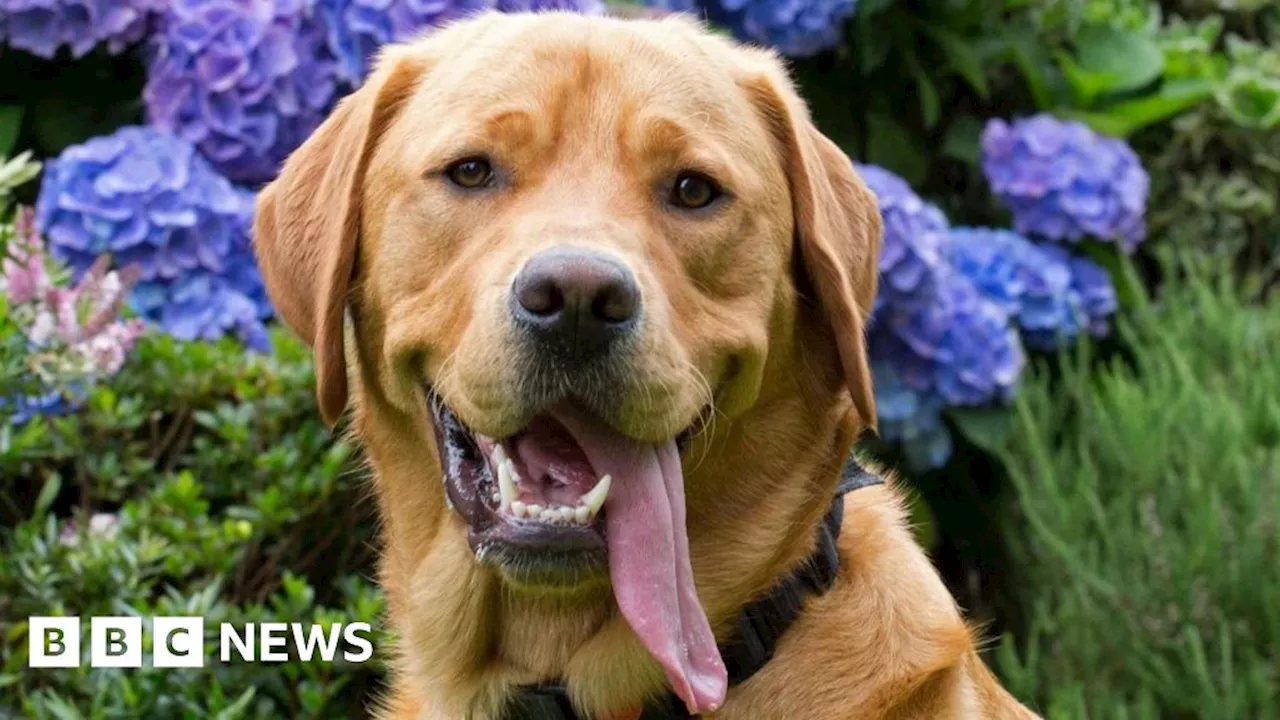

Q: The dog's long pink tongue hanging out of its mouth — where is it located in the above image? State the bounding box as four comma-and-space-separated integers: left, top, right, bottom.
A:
556, 410, 728, 715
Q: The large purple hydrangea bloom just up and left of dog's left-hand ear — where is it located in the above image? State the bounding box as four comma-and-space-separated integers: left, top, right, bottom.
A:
142, 0, 338, 184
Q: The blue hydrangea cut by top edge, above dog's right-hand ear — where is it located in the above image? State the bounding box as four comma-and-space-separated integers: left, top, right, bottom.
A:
648, 0, 856, 58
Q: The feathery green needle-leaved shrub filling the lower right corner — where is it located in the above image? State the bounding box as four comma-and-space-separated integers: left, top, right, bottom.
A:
1000, 254, 1280, 720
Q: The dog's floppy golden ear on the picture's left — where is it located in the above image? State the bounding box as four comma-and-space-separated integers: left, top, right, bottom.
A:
253, 47, 426, 428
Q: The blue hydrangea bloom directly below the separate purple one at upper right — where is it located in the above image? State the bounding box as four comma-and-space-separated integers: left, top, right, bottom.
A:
946, 228, 1080, 348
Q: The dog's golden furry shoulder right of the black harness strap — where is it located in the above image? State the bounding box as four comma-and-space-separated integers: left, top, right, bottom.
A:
726, 469, 1034, 720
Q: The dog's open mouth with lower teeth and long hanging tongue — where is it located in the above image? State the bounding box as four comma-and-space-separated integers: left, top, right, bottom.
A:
428, 392, 727, 715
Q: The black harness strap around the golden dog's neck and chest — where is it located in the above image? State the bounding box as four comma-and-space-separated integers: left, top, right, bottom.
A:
500, 455, 884, 720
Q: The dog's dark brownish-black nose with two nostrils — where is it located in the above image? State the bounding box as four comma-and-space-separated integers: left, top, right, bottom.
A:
511, 250, 640, 360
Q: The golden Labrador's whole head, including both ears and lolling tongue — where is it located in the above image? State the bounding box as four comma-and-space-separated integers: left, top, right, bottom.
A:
256, 14, 881, 707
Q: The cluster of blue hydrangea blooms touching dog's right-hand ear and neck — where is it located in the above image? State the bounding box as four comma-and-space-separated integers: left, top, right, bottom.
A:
856, 158, 1116, 470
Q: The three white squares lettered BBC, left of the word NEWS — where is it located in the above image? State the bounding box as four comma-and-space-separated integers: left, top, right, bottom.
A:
27, 616, 205, 667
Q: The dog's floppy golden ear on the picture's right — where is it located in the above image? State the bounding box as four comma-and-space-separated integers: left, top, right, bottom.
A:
742, 51, 883, 428
